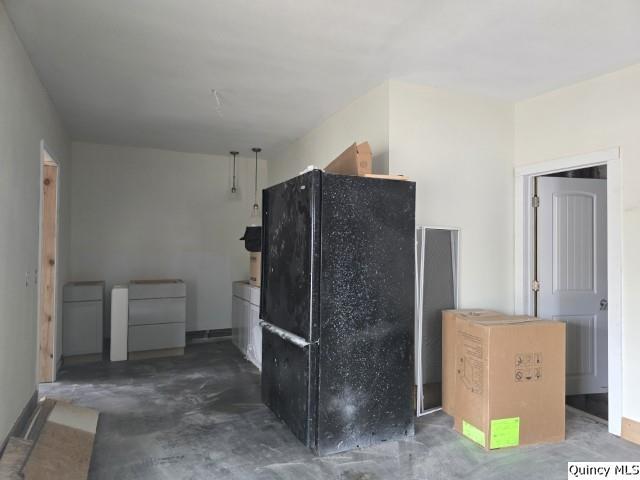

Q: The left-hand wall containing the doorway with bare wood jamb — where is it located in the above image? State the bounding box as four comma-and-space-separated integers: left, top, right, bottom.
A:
0, 2, 69, 442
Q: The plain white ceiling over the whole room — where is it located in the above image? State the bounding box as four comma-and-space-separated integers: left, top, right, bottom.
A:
4, 0, 640, 158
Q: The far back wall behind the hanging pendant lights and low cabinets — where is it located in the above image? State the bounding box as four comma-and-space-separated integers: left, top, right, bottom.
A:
71, 142, 266, 330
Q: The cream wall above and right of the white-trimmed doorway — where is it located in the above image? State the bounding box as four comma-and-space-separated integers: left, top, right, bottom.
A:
515, 65, 640, 421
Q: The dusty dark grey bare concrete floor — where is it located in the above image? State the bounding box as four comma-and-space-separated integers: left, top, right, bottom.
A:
40, 341, 640, 480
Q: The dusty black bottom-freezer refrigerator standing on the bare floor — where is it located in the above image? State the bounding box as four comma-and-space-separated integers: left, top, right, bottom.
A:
260, 170, 415, 455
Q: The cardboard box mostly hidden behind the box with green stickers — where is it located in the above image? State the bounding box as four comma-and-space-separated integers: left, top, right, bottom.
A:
442, 308, 504, 416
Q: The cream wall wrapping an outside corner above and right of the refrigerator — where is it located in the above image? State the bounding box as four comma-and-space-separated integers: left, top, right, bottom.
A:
269, 81, 513, 312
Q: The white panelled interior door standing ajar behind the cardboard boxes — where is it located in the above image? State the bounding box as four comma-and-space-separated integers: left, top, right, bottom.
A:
537, 177, 608, 395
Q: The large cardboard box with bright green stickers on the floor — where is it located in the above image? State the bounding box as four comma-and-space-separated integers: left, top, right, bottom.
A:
455, 317, 566, 450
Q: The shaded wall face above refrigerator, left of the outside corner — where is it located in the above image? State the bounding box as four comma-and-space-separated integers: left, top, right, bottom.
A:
269, 82, 389, 185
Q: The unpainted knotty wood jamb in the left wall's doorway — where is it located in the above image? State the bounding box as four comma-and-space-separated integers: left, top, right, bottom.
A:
38, 144, 58, 383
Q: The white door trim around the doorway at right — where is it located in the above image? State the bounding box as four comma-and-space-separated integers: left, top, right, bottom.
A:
514, 147, 622, 436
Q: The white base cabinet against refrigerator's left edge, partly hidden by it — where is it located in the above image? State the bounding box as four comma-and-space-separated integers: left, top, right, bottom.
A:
231, 282, 262, 370
